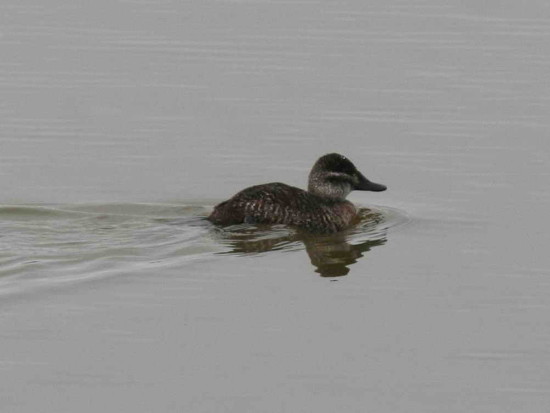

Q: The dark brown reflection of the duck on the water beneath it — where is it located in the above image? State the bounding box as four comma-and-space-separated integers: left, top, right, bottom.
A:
215, 209, 386, 277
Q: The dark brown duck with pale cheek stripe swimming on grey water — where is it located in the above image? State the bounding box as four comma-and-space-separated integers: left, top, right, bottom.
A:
207, 153, 387, 234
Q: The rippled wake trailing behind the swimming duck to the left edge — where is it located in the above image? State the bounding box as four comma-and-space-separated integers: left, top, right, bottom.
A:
0, 204, 216, 291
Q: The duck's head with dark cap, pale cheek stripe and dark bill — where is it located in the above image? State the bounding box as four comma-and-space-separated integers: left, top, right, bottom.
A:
307, 153, 386, 200
